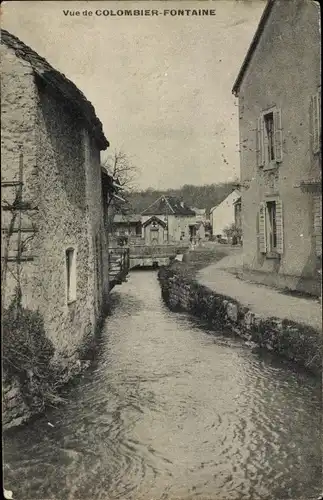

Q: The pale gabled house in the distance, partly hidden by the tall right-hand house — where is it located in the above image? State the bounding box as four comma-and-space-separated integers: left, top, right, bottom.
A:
210, 189, 240, 239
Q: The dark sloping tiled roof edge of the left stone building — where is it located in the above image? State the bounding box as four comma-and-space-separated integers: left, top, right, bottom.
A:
1, 29, 109, 150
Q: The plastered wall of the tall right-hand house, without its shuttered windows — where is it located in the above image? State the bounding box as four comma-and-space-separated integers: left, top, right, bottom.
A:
239, 0, 321, 286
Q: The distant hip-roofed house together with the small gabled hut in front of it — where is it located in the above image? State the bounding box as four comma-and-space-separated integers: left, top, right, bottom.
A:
141, 196, 196, 244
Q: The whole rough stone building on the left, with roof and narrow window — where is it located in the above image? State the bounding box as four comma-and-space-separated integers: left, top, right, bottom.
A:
1, 30, 114, 364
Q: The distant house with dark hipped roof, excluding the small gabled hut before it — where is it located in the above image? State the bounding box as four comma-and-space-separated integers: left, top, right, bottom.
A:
141, 196, 196, 243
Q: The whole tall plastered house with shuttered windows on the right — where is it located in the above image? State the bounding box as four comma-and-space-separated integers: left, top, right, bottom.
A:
233, 0, 322, 294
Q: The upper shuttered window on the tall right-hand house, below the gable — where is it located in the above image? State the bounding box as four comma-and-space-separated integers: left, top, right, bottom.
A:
256, 108, 283, 168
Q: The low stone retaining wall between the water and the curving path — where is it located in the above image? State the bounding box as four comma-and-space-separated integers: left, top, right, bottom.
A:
158, 267, 322, 374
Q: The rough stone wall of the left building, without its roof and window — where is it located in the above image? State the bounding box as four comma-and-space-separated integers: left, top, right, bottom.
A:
1, 44, 109, 425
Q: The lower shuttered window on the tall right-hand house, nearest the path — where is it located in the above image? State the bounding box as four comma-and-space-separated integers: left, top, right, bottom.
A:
259, 199, 284, 256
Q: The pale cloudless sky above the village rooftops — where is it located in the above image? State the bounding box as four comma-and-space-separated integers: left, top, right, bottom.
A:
1, 0, 265, 189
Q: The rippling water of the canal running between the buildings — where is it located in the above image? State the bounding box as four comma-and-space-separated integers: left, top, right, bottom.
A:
4, 271, 321, 500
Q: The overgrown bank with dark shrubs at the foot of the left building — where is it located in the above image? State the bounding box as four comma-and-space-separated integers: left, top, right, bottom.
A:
2, 306, 108, 431
